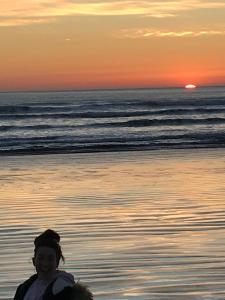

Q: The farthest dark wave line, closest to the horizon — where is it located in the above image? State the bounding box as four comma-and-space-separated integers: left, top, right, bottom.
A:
0, 95, 225, 116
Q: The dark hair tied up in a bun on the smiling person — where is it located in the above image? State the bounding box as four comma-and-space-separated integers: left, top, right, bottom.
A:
34, 229, 65, 266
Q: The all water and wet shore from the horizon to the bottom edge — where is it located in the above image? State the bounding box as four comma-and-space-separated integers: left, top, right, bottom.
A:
0, 87, 225, 300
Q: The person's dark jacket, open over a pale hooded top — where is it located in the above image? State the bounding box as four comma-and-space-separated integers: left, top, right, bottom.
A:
14, 274, 73, 300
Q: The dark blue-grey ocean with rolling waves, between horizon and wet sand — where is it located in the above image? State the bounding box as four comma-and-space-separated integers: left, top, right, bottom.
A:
0, 87, 225, 154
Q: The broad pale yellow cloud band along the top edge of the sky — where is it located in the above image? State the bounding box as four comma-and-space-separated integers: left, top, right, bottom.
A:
0, 0, 225, 26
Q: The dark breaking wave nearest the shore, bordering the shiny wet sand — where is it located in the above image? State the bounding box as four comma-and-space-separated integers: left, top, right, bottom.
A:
0, 132, 225, 154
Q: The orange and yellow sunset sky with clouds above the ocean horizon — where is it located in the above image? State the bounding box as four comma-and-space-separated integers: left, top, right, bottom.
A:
0, 0, 225, 91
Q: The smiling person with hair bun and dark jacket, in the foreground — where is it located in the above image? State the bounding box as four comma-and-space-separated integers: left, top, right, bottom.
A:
14, 229, 93, 300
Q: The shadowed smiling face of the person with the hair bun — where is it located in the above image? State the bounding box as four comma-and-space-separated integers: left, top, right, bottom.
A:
33, 247, 58, 279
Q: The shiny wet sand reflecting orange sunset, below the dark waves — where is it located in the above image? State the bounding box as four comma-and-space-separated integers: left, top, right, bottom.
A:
0, 149, 225, 300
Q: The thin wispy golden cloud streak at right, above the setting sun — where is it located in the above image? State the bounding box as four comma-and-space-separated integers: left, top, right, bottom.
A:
118, 28, 225, 39
